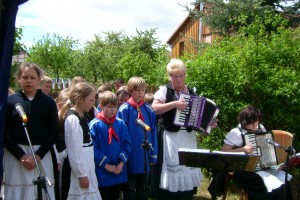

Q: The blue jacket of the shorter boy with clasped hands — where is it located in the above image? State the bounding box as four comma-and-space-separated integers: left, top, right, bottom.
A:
89, 118, 131, 187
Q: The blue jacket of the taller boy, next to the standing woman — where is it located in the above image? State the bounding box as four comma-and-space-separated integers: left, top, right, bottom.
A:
117, 102, 158, 174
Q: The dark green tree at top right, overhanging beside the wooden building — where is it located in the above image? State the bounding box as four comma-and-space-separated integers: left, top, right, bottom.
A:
183, 0, 300, 36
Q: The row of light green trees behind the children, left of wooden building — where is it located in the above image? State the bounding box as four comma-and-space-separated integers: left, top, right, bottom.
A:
27, 29, 169, 88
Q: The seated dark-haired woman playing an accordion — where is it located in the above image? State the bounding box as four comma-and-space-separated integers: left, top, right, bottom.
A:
221, 105, 291, 200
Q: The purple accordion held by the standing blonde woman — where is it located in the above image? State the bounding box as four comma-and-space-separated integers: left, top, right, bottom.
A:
173, 93, 220, 135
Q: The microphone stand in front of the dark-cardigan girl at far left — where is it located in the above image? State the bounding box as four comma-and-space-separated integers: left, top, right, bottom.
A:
22, 120, 51, 200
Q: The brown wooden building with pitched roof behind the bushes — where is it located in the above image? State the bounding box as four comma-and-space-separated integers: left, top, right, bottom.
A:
167, 4, 216, 58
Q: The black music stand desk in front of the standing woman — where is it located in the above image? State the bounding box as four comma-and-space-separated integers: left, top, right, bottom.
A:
178, 148, 260, 172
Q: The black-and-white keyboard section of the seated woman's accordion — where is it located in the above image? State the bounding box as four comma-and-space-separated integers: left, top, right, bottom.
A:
243, 132, 277, 171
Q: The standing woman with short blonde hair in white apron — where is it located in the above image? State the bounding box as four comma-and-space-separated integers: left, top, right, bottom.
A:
152, 59, 207, 199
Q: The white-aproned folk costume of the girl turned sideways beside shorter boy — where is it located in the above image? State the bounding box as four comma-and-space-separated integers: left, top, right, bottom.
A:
62, 109, 101, 200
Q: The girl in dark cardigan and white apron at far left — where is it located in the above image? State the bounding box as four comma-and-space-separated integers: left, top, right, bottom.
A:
3, 63, 59, 199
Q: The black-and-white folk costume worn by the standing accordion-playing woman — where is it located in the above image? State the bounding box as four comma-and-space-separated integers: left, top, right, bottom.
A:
154, 84, 203, 199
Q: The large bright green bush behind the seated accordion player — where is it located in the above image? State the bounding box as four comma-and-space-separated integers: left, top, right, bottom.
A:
183, 17, 300, 149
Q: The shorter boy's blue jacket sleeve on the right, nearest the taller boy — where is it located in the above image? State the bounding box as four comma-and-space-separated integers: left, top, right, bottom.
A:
118, 121, 131, 164
